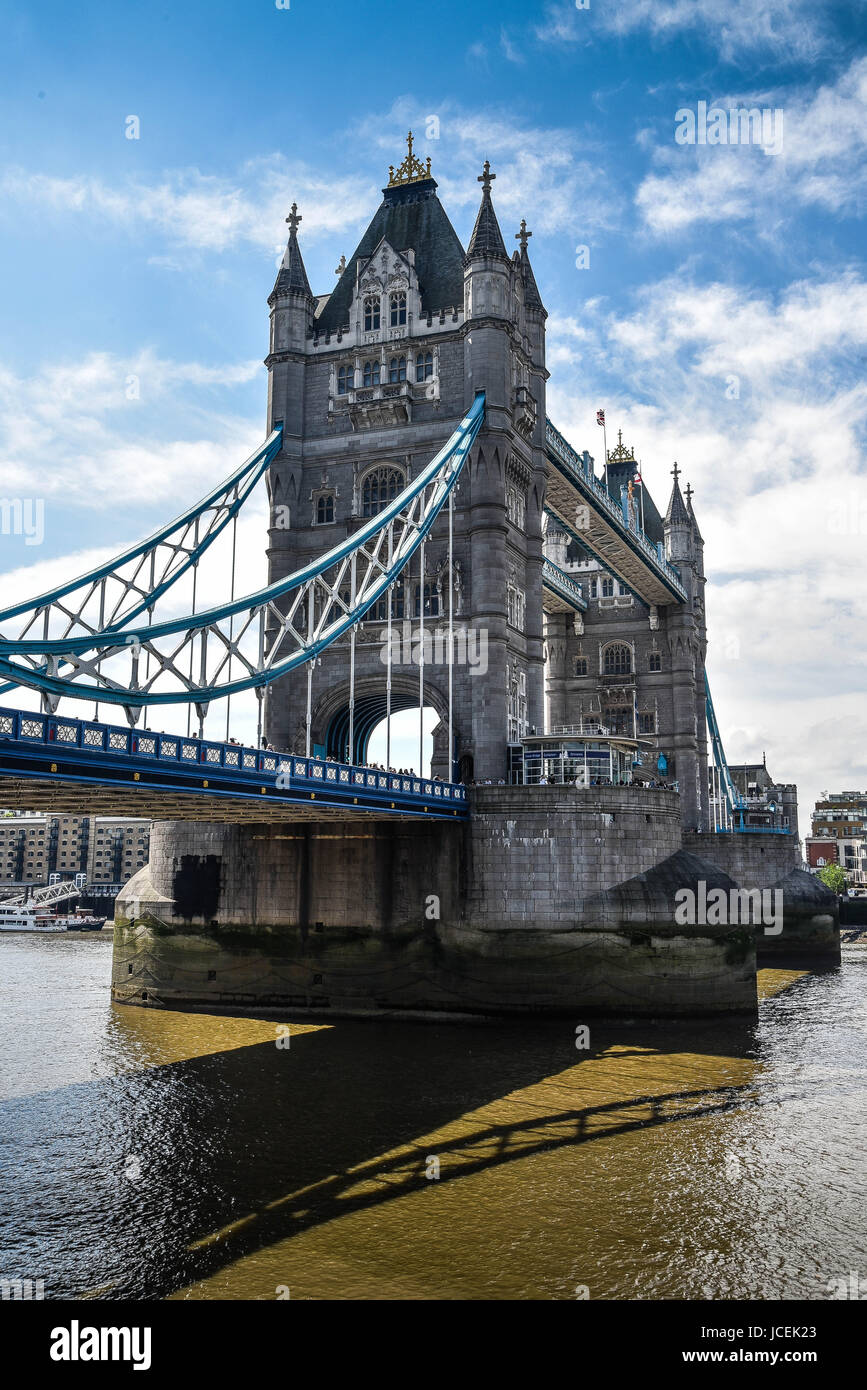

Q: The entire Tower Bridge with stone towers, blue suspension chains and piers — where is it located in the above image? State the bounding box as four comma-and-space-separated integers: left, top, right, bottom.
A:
0, 143, 831, 1013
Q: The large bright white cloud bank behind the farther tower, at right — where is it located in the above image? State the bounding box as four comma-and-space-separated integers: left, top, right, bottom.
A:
547, 272, 867, 833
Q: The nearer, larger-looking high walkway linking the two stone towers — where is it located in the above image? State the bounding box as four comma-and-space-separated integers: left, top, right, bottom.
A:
545, 420, 686, 605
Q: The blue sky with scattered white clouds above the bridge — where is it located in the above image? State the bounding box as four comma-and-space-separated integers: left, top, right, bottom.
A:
0, 0, 867, 827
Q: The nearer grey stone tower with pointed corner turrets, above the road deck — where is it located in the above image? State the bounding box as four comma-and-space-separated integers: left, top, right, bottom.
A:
265, 143, 547, 780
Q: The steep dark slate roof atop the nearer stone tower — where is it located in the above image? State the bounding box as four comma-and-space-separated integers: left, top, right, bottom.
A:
317, 178, 464, 331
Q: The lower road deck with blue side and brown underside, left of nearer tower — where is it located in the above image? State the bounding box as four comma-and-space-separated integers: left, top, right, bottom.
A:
0, 709, 468, 823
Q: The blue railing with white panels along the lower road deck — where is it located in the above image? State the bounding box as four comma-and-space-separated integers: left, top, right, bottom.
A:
0, 709, 468, 813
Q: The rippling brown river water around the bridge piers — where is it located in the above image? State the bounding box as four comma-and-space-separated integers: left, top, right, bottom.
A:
0, 934, 867, 1300
